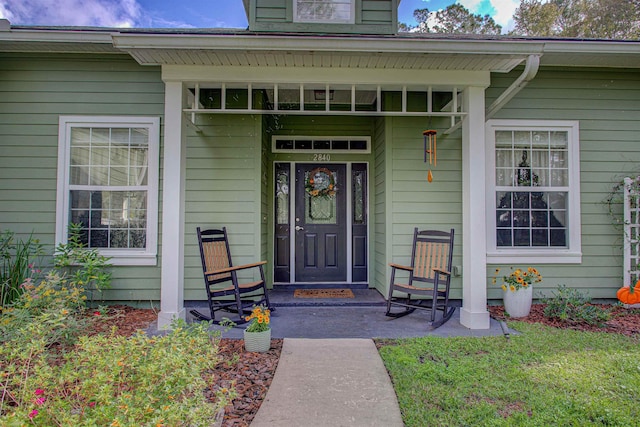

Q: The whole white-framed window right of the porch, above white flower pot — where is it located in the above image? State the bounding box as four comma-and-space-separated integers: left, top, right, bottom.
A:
486, 120, 581, 263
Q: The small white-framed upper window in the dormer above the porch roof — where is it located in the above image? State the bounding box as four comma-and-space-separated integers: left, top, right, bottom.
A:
293, 0, 355, 24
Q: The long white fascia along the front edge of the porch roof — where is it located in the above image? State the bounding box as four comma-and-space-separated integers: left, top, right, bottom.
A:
113, 34, 544, 55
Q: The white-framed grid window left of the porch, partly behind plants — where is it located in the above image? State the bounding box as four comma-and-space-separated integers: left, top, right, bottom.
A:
56, 116, 160, 265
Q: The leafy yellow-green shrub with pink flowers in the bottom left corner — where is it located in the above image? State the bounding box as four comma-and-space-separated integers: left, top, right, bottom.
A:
0, 322, 234, 426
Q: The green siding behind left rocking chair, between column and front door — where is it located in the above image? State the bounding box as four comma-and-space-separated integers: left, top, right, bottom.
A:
184, 115, 263, 300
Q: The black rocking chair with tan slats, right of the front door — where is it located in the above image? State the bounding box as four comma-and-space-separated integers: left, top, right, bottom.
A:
386, 228, 456, 329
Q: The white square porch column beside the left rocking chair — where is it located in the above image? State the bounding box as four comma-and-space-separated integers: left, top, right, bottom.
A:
158, 82, 186, 329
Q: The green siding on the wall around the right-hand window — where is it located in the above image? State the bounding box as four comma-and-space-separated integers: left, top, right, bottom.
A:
487, 69, 640, 299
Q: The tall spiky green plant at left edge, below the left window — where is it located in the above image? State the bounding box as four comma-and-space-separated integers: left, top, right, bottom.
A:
0, 230, 44, 307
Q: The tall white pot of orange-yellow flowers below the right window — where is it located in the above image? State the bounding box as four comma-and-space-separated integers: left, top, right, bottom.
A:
494, 267, 542, 317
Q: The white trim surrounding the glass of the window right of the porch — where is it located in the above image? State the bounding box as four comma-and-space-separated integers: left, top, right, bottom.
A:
485, 120, 582, 264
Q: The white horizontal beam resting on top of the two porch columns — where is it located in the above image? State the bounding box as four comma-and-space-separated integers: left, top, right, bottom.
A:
162, 65, 491, 87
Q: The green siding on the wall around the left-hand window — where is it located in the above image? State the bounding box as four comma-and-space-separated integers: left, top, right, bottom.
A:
0, 53, 164, 302
